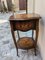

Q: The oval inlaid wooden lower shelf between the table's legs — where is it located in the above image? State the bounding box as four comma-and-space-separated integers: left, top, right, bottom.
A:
17, 37, 35, 49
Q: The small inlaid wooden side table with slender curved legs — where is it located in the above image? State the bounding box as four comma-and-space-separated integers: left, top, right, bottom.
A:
9, 13, 41, 55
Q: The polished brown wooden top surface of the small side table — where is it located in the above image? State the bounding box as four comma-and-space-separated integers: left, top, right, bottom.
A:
9, 13, 41, 21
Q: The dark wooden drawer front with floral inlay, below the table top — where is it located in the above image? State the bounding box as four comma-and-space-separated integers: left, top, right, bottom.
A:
14, 21, 36, 31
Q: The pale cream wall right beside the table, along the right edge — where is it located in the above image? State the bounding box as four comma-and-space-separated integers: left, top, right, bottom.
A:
35, 0, 45, 60
